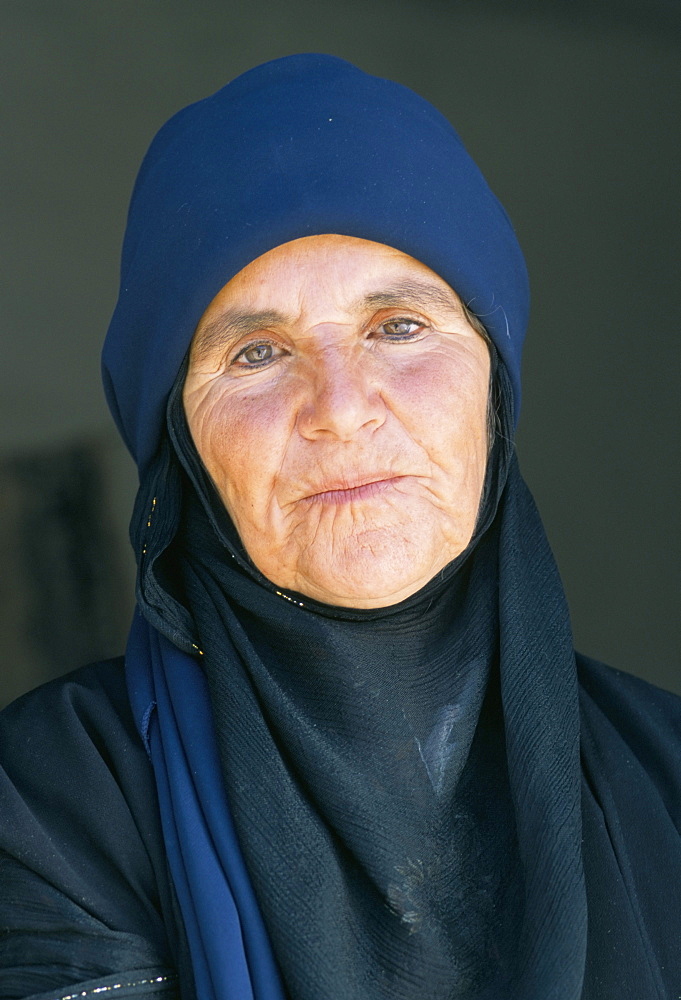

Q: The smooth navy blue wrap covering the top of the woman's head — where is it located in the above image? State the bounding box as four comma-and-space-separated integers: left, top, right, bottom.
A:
103, 55, 528, 470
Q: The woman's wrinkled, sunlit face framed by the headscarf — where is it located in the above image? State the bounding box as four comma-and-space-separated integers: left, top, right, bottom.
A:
183, 235, 490, 608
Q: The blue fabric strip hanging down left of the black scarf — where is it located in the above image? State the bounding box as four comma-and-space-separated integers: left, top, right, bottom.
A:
126, 613, 284, 1000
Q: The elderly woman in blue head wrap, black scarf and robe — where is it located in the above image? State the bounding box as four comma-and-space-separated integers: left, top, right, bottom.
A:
0, 56, 681, 1000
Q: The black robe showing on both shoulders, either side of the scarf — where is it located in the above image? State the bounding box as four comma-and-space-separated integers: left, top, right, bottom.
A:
0, 656, 681, 1000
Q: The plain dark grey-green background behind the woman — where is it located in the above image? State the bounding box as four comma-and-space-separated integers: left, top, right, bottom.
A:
0, 0, 681, 701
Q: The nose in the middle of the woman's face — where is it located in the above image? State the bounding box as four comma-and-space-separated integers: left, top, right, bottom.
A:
298, 347, 386, 441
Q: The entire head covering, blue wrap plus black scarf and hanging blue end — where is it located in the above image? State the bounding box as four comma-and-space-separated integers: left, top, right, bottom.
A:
109, 56, 586, 1000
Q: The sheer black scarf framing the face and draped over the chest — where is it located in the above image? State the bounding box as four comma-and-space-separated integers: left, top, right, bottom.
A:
118, 356, 585, 1000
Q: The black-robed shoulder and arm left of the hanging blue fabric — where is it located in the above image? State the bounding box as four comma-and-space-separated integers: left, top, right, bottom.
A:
0, 659, 186, 996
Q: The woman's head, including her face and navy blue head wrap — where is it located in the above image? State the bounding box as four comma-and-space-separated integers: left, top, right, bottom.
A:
99, 55, 528, 607
